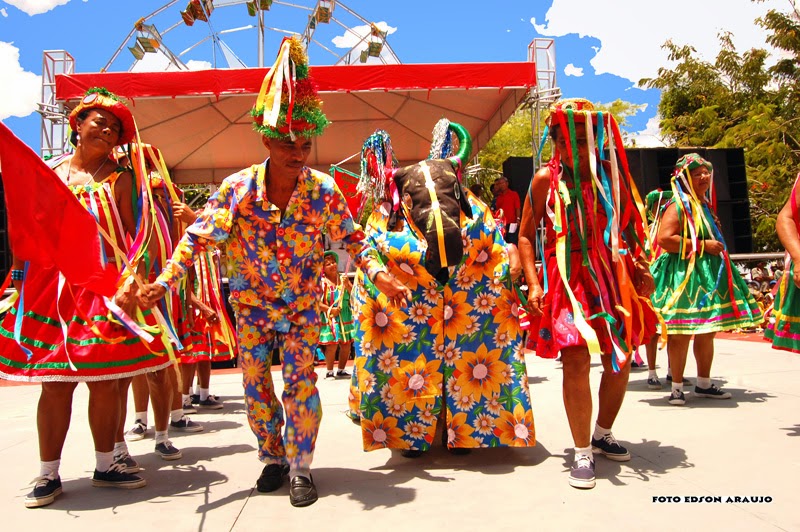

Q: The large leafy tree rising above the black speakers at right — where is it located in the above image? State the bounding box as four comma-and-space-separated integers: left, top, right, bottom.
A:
639, 1, 800, 251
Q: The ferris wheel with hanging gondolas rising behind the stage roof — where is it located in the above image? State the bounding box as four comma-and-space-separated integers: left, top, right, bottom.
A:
103, 0, 400, 72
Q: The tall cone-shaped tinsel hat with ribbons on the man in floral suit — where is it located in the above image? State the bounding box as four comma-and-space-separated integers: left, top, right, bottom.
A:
250, 37, 329, 140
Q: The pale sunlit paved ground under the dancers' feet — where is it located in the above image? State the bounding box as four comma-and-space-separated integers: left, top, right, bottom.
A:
0, 340, 800, 532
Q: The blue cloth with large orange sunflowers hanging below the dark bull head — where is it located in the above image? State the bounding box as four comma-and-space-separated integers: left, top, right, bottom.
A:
351, 194, 535, 451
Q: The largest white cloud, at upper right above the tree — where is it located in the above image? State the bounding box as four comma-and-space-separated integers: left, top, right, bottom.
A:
531, 0, 787, 83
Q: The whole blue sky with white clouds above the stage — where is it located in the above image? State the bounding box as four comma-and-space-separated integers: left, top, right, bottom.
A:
0, 0, 793, 151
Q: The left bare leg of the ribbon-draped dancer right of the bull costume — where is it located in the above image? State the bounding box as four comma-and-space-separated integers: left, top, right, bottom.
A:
561, 347, 592, 447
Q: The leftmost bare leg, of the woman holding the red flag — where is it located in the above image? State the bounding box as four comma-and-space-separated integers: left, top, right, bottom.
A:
36, 382, 78, 462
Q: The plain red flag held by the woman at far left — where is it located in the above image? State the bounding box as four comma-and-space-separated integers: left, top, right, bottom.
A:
0, 122, 119, 297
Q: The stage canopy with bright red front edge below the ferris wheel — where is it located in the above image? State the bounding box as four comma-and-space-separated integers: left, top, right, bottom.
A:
56, 63, 536, 183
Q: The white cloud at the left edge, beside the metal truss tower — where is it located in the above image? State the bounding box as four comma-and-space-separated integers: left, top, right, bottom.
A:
0, 41, 42, 120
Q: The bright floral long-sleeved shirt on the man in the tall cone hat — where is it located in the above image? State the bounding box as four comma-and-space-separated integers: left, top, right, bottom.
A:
157, 159, 385, 330
